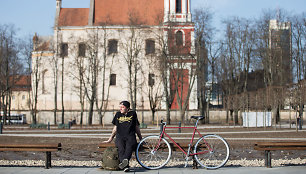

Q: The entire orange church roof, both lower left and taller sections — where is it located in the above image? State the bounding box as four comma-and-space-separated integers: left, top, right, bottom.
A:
58, 0, 164, 26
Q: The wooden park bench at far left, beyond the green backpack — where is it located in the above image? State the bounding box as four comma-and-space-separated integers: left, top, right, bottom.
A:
0, 143, 62, 169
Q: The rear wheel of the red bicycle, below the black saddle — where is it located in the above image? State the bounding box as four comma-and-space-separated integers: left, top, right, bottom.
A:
194, 135, 229, 169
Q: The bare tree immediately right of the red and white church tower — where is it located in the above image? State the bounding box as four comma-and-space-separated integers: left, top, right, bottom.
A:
193, 8, 215, 123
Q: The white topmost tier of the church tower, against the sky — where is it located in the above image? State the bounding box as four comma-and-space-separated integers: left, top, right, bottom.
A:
164, 0, 191, 22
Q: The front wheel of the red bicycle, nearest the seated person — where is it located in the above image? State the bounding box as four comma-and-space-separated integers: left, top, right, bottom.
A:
136, 136, 171, 169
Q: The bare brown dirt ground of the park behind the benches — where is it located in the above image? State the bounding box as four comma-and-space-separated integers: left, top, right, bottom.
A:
0, 124, 306, 161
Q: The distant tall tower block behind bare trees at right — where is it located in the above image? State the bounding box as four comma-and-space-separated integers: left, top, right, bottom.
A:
269, 20, 292, 86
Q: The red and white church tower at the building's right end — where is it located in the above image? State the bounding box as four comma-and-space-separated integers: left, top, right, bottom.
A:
164, 0, 196, 110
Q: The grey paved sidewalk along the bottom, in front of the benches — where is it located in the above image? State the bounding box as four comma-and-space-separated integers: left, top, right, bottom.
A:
0, 165, 306, 174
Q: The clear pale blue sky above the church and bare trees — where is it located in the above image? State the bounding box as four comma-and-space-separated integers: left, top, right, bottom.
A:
0, 0, 306, 37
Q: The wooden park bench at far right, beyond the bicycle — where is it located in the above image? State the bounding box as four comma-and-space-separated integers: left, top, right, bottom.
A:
254, 142, 306, 168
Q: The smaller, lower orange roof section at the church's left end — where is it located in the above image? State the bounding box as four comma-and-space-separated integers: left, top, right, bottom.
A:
58, 8, 89, 26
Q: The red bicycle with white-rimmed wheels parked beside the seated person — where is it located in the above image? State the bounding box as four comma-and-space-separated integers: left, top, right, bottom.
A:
136, 116, 229, 169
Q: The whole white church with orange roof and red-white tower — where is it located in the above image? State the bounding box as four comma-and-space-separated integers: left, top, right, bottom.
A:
32, 0, 197, 125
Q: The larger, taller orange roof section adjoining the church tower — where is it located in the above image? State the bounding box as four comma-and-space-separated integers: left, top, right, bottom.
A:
94, 0, 164, 25
